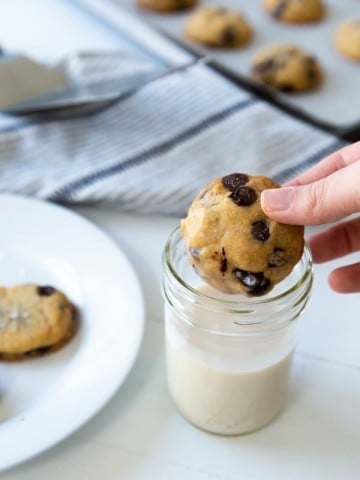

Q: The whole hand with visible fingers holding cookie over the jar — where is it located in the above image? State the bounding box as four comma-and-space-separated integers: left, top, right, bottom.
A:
261, 142, 360, 293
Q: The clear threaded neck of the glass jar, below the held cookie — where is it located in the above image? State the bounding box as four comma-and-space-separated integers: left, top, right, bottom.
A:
162, 228, 313, 335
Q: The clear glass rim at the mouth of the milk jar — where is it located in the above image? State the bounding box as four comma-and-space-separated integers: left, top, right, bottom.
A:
163, 226, 312, 310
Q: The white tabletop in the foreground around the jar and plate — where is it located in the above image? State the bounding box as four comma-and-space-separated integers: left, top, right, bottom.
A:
1, 208, 360, 480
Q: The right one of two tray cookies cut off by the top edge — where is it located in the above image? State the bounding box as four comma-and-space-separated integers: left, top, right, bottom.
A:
263, 0, 325, 23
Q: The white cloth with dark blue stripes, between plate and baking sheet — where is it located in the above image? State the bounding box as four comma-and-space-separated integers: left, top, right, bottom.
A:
0, 51, 342, 215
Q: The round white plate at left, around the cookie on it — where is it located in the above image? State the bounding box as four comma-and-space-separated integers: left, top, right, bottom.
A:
0, 195, 144, 471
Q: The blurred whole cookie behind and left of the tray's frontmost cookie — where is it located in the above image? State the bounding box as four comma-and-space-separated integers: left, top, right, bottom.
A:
184, 5, 252, 48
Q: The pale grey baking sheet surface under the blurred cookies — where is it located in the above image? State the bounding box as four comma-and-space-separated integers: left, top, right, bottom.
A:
113, 0, 360, 131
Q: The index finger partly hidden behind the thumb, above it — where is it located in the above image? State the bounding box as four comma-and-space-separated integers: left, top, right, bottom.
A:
284, 141, 360, 186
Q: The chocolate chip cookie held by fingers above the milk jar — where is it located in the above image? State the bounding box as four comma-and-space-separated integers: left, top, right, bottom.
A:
181, 173, 304, 296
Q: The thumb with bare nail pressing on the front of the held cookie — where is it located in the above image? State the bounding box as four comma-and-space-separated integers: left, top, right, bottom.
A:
261, 163, 360, 225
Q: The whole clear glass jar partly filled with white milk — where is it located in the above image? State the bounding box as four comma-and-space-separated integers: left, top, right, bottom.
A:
162, 229, 312, 435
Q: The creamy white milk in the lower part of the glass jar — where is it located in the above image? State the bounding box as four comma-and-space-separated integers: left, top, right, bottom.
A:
166, 302, 293, 435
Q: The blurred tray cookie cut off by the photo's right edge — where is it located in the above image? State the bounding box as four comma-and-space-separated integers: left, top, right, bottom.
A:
334, 17, 360, 61
